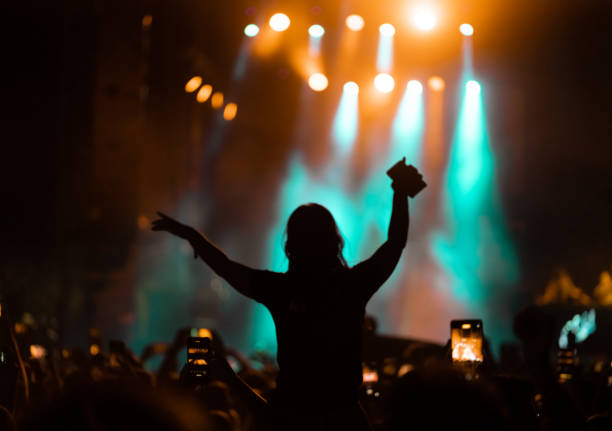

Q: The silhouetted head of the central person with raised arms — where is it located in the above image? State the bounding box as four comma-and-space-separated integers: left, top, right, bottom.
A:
285, 203, 346, 270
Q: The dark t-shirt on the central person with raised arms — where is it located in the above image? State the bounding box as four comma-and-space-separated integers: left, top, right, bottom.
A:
250, 244, 403, 405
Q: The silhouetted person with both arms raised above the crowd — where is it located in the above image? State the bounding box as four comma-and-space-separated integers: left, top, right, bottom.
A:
153, 160, 424, 430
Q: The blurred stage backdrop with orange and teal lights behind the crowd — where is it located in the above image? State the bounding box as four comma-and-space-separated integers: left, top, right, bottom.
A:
0, 0, 612, 362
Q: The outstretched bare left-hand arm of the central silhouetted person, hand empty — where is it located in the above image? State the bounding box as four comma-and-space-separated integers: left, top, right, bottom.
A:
152, 212, 272, 301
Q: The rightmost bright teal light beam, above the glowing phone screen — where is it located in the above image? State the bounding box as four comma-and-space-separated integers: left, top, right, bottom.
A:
432, 80, 519, 352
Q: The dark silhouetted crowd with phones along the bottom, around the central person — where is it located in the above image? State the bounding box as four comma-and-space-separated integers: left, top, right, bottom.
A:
0, 306, 612, 431
